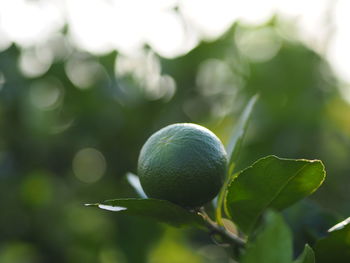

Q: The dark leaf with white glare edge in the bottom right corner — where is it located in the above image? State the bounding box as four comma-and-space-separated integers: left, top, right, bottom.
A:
315, 217, 350, 263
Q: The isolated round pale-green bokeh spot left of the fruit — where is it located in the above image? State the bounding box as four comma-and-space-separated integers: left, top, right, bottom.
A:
73, 148, 107, 183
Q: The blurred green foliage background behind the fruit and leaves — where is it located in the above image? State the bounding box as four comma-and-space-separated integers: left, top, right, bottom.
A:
0, 3, 350, 263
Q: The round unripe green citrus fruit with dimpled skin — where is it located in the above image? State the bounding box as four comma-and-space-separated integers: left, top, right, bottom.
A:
137, 123, 227, 208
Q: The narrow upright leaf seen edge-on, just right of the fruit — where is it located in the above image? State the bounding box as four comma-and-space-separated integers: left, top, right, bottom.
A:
216, 95, 259, 225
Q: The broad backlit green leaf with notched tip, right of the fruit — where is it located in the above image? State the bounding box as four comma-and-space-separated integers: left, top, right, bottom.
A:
225, 156, 326, 234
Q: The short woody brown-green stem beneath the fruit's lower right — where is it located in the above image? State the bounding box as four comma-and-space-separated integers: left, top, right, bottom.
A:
198, 207, 246, 248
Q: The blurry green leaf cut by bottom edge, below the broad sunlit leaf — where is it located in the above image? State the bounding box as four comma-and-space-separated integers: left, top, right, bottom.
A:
241, 211, 292, 263
